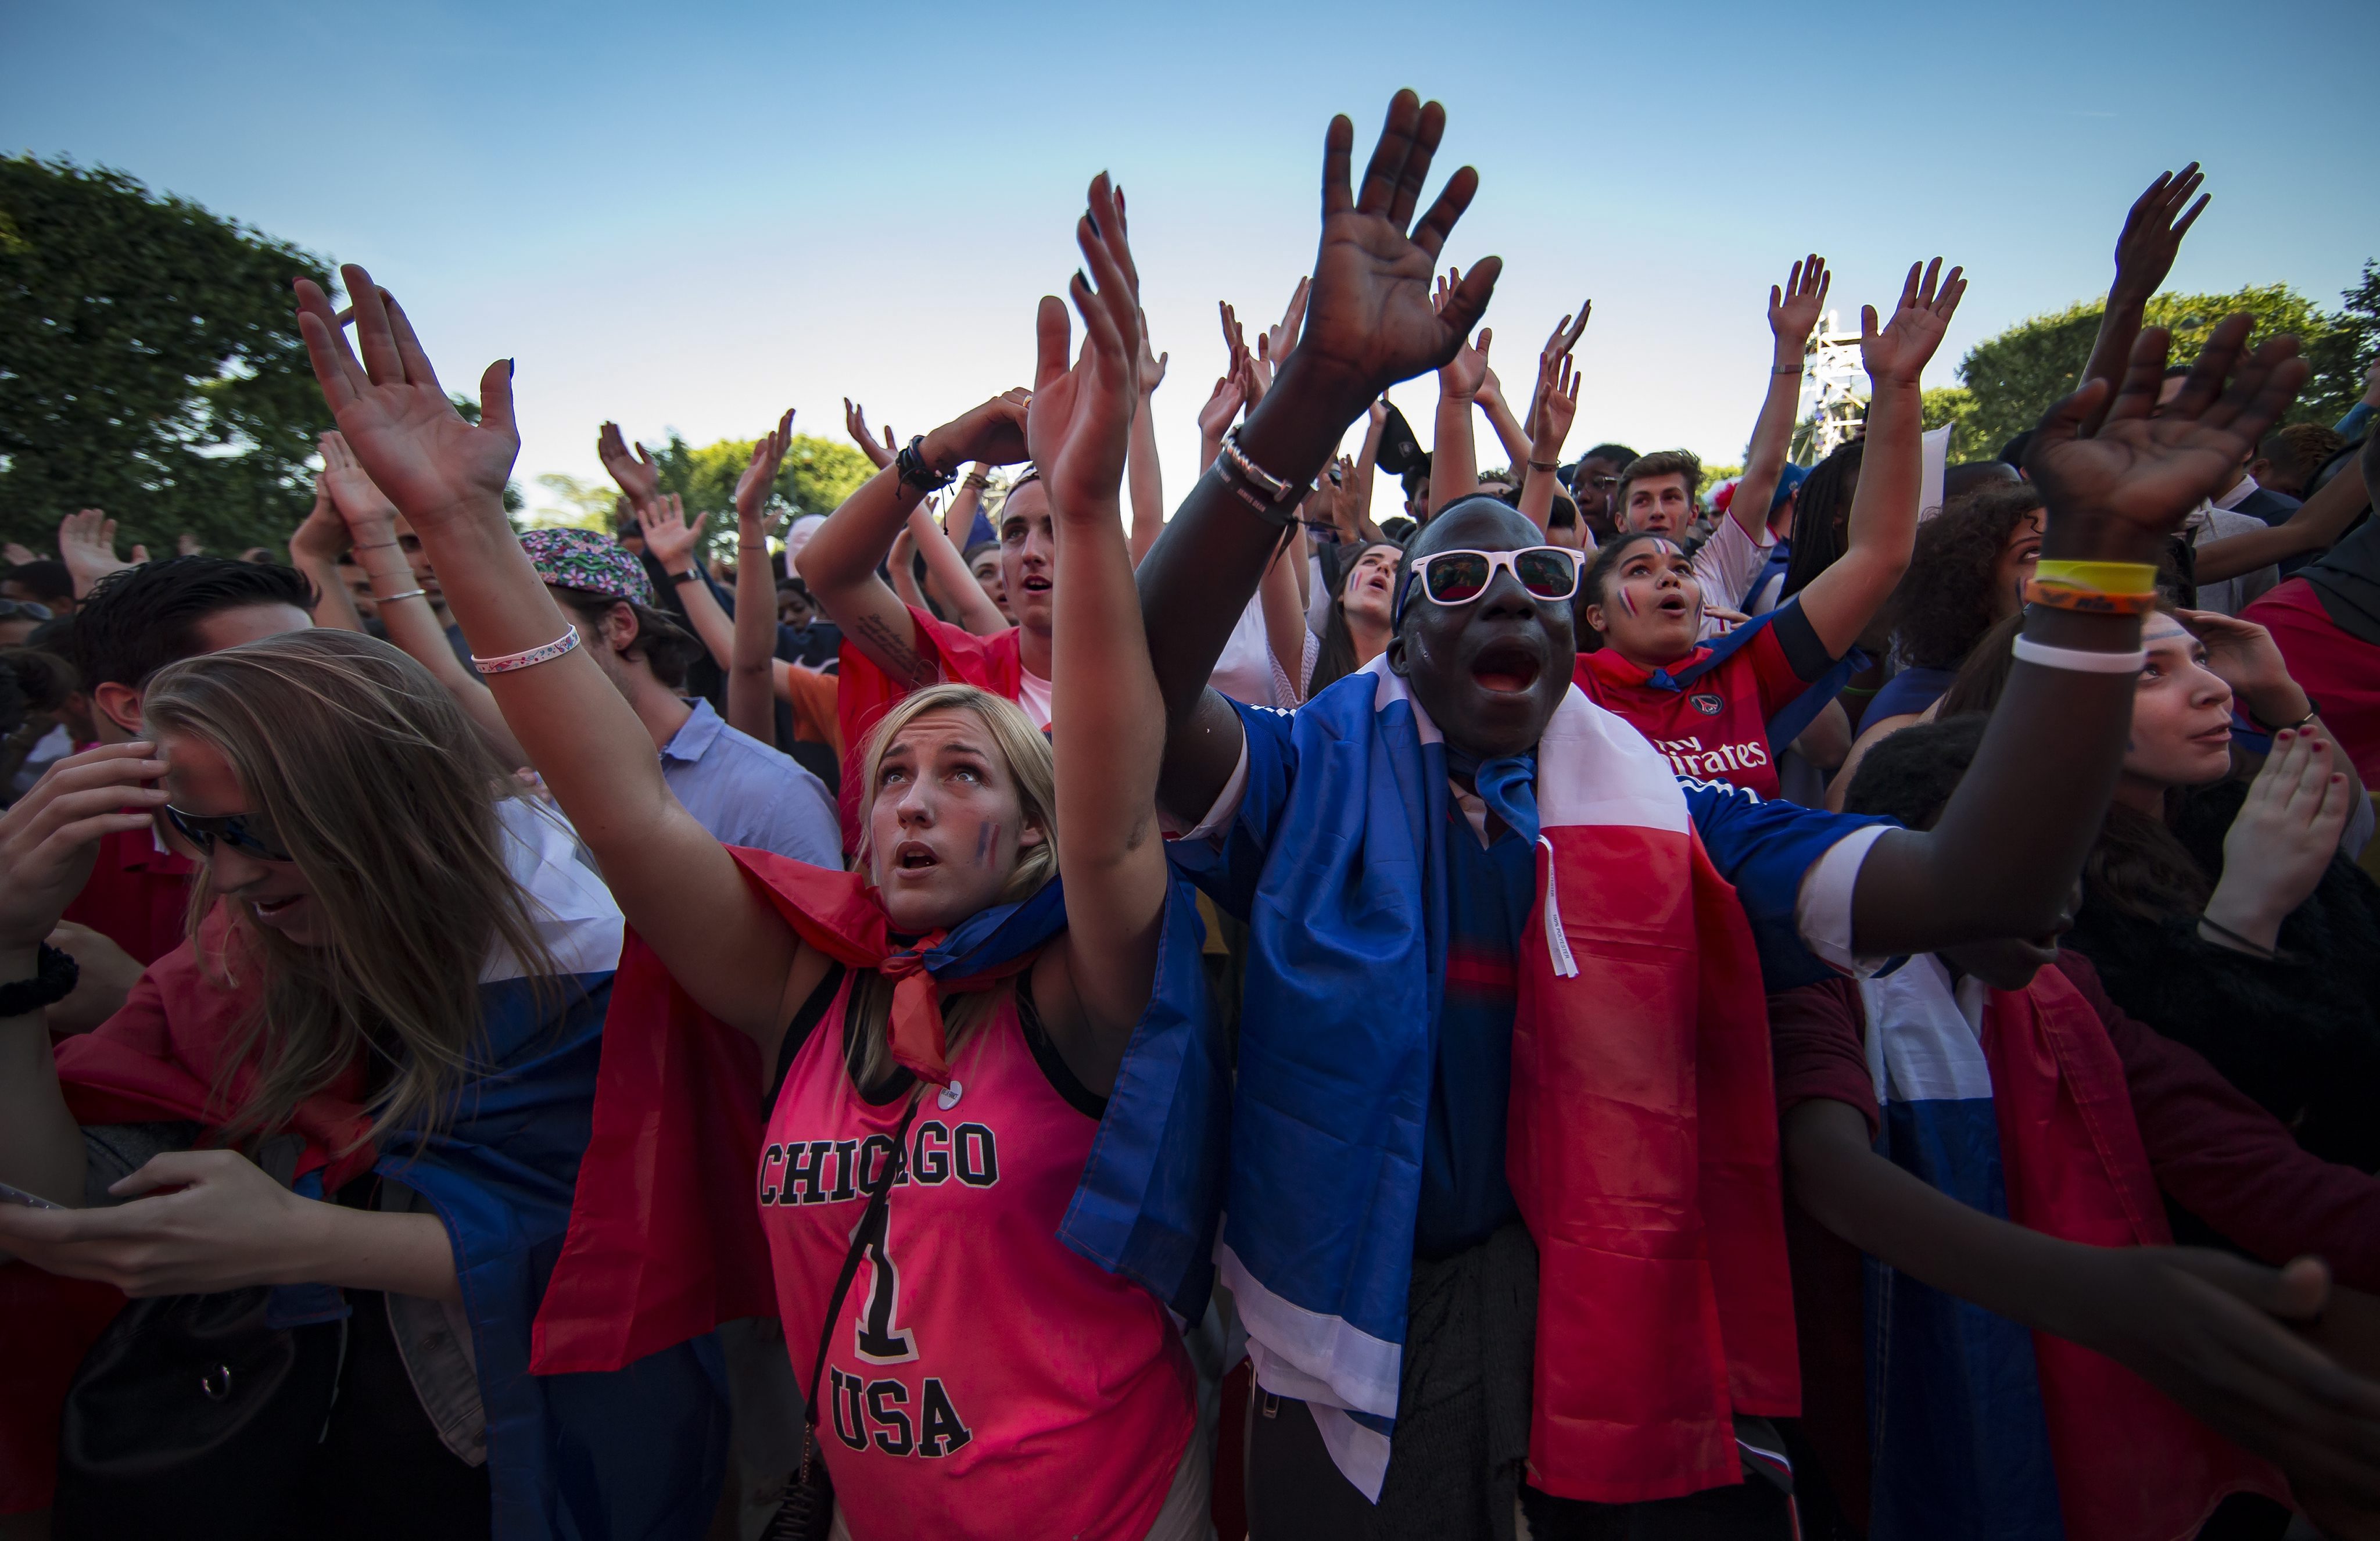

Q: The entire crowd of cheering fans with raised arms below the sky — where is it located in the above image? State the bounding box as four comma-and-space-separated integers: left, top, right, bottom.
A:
0, 93, 2380, 1541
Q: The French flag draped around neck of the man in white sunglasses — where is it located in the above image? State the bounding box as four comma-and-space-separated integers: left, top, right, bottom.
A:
1185, 660, 1800, 1503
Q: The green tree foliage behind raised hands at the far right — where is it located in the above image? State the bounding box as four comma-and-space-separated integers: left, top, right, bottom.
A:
1926, 274, 2380, 460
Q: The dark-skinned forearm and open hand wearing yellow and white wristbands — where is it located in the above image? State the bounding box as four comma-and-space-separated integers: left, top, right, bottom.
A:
1852, 312, 2306, 958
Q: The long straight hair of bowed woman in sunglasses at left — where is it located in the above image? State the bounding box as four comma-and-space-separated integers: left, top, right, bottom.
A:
141, 629, 554, 1143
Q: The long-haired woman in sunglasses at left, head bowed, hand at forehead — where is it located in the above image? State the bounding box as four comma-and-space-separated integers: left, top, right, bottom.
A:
0, 631, 723, 1536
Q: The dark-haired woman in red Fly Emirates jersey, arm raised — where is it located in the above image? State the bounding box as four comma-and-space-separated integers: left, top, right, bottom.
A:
1571, 260, 1966, 798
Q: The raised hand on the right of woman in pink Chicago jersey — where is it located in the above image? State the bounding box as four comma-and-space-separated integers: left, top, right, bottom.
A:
1026, 171, 1142, 519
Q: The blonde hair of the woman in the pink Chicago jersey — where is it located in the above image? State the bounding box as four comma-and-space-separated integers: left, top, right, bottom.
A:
845, 683, 1057, 1091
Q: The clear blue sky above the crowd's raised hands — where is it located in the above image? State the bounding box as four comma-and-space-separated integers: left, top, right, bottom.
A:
0, 0, 2380, 524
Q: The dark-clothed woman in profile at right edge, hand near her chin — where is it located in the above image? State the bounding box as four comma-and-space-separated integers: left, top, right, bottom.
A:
2066, 610, 2380, 1172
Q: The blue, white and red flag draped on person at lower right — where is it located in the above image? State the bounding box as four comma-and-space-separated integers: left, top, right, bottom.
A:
1859, 955, 2287, 1541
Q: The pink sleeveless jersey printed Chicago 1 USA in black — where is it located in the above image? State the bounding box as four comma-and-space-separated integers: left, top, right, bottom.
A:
759, 979, 1195, 1541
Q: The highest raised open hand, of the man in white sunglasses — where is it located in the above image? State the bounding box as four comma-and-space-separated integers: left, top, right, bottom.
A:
1297, 91, 1504, 417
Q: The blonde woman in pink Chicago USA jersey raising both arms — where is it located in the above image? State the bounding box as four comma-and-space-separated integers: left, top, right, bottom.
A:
298, 176, 1209, 1541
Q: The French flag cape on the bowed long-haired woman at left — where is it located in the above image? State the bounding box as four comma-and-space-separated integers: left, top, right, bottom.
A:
0, 800, 726, 1541
